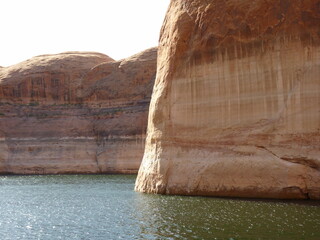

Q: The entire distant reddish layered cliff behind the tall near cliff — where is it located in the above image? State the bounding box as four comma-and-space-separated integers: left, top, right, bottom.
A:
0, 48, 157, 174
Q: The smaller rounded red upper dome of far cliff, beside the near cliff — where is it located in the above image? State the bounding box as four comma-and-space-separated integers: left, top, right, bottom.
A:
81, 48, 157, 103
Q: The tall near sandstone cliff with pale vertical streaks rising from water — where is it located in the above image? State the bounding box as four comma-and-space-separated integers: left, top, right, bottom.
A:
136, 0, 320, 199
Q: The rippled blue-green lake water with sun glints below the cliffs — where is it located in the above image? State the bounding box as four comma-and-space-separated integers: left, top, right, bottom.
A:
0, 175, 320, 240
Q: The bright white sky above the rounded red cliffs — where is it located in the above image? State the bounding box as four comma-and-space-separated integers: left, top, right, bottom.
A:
0, 0, 170, 67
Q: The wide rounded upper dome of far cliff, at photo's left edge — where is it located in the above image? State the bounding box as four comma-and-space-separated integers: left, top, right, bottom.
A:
0, 52, 114, 104
